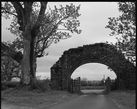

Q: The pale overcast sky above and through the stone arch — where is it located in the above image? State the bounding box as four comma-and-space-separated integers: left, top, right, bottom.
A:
2, 2, 119, 80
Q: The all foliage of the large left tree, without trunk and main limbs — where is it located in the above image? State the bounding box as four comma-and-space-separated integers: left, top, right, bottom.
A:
3, 2, 81, 57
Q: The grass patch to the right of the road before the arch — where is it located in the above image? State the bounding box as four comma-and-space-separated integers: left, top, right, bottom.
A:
107, 91, 136, 109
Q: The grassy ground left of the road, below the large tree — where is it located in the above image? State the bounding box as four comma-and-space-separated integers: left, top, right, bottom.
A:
1, 89, 78, 109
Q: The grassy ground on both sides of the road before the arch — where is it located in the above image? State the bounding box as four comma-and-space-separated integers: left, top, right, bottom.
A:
1, 88, 136, 109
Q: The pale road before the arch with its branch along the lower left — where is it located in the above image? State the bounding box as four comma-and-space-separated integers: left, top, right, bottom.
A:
1, 94, 119, 109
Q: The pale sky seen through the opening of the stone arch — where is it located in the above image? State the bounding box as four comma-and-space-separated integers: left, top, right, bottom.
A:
71, 63, 117, 81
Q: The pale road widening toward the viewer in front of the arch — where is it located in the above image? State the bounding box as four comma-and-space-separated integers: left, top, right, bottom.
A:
49, 93, 119, 109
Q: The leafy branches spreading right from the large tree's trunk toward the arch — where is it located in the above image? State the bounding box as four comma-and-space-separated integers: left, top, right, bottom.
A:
35, 4, 81, 57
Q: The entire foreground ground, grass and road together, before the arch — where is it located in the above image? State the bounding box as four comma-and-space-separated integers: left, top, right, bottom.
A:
1, 90, 135, 109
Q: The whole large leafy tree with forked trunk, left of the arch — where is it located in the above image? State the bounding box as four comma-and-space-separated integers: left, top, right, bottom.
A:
1, 1, 81, 85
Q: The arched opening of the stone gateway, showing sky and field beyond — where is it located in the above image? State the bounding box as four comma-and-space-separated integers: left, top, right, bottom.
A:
71, 63, 117, 94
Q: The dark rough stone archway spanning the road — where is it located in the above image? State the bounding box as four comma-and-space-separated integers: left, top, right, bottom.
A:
51, 43, 136, 90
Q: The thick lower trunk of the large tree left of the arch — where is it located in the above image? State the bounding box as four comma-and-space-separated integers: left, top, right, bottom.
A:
21, 26, 36, 87
